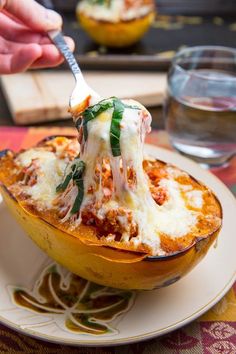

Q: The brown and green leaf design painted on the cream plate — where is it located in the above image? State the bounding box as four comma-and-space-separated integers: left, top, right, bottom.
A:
12, 264, 135, 335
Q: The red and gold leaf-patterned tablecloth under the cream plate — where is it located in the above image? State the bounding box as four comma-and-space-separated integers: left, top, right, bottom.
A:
0, 127, 236, 354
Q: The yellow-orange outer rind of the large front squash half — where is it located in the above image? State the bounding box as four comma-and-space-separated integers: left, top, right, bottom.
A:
0, 185, 219, 290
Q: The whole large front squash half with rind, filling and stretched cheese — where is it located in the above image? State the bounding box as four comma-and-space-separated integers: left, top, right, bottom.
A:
0, 97, 222, 289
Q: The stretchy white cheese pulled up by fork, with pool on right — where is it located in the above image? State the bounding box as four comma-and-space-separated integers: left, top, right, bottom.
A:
58, 99, 201, 255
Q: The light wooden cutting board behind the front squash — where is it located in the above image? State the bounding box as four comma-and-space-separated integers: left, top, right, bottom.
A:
1, 71, 166, 125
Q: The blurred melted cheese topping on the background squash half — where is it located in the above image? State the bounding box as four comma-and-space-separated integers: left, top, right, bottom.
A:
78, 0, 154, 23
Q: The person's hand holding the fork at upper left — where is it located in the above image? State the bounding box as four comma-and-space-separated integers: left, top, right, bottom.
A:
0, 0, 74, 74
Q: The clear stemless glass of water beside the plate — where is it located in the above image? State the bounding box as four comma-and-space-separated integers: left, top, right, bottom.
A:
164, 46, 236, 165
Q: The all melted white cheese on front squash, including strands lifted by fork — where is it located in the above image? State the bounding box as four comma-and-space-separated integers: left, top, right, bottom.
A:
13, 100, 206, 255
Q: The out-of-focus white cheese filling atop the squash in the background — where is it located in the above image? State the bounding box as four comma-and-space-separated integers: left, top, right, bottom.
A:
78, 0, 153, 23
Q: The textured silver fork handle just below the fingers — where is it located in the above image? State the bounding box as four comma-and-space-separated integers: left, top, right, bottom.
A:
48, 30, 82, 79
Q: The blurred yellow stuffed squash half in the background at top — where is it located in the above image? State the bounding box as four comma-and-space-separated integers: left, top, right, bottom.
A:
76, 0, 155, 48
